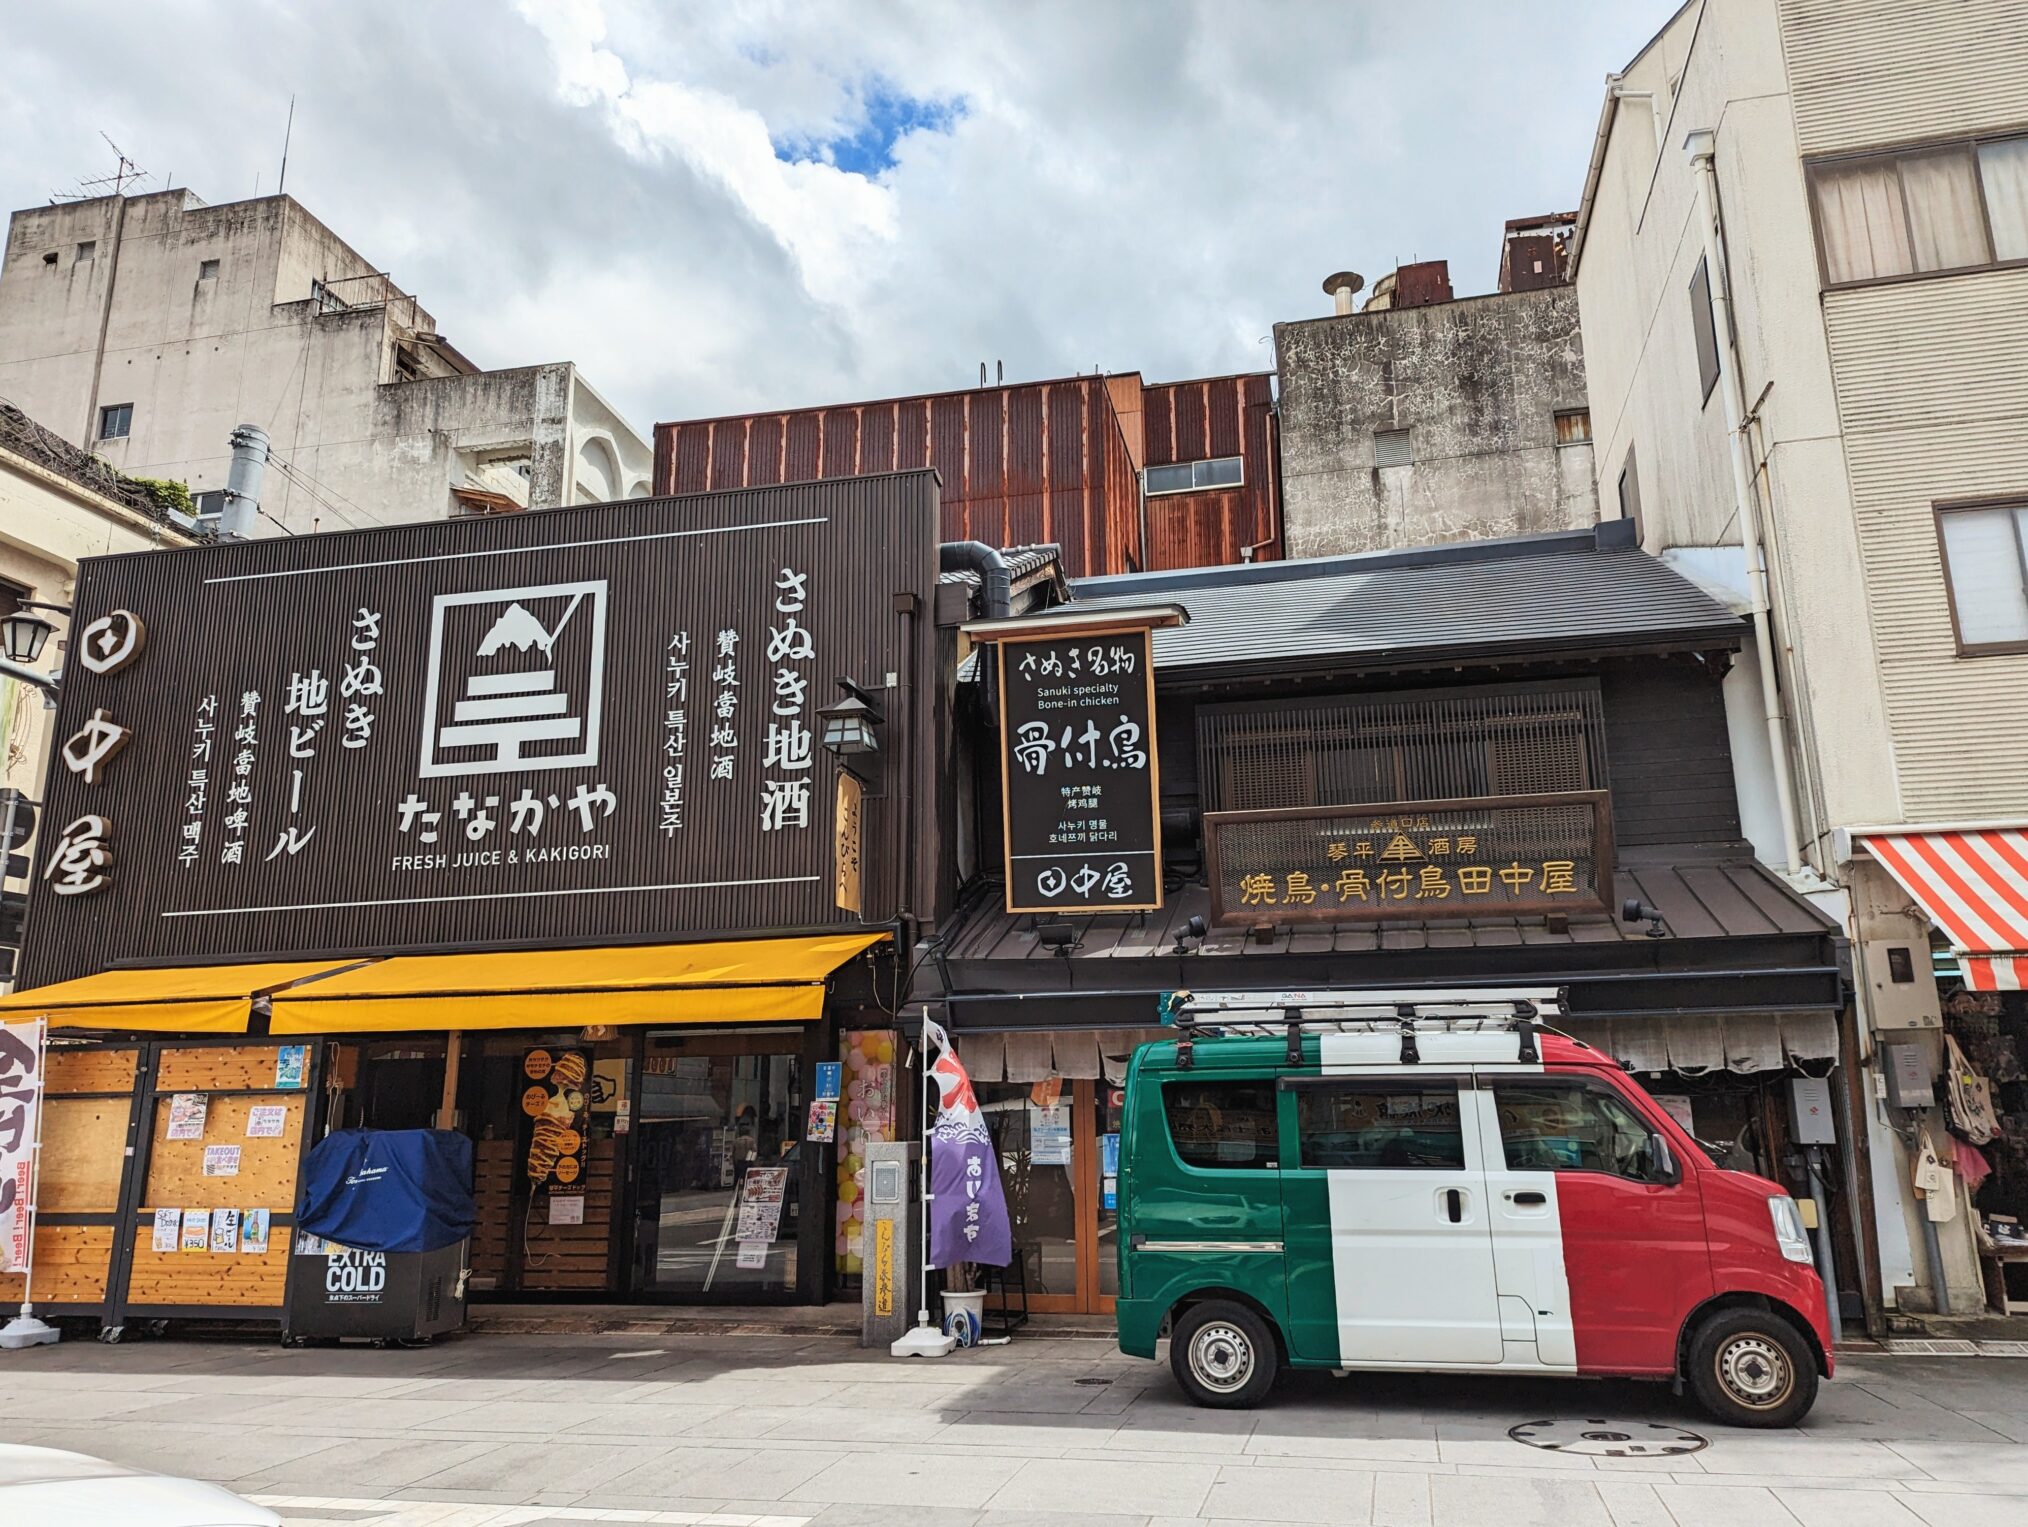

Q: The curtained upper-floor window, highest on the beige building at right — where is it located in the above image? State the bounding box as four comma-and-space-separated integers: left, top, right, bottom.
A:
1809, 136, 2028, 286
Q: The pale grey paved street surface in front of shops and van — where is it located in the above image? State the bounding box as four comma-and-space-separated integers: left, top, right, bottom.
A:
0, 1334, 2028, 1527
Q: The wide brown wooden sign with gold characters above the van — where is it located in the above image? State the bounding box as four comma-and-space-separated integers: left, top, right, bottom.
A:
1205, 791, 1612, 923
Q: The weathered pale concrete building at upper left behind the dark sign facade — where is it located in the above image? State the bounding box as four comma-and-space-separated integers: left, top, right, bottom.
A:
0, 191, 651, 533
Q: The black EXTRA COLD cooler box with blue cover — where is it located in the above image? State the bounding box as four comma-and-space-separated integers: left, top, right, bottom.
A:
282, 1130, 475, 1342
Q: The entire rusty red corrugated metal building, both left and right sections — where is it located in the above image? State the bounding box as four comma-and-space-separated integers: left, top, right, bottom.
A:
655, 373, 1280, 578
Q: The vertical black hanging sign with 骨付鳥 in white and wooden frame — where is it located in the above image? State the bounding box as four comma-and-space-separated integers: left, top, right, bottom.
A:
1000, 627, 1162, 913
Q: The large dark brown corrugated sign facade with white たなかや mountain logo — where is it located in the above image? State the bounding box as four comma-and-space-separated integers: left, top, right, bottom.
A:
24, 472, 937, 986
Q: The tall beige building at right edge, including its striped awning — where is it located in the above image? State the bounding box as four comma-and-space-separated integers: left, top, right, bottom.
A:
1573, 0, 2028, 1312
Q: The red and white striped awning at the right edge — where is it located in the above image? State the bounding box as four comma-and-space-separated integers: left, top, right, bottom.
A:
1860, 829, 2028, 992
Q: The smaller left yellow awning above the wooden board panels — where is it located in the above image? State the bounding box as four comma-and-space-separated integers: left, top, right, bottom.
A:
0, 959, 371, 1034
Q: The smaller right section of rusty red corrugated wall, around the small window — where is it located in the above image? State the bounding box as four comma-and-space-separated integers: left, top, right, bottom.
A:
1142, 373, 1282, 570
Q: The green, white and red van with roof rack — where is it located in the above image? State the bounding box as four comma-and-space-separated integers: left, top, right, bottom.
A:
1117, 992, 1831, 1426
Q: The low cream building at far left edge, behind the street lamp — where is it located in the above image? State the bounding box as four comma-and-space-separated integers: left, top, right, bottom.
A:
0, 399, 195, 965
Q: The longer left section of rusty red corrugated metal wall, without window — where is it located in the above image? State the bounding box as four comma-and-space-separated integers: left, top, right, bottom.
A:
655, 375, 1146, 578
